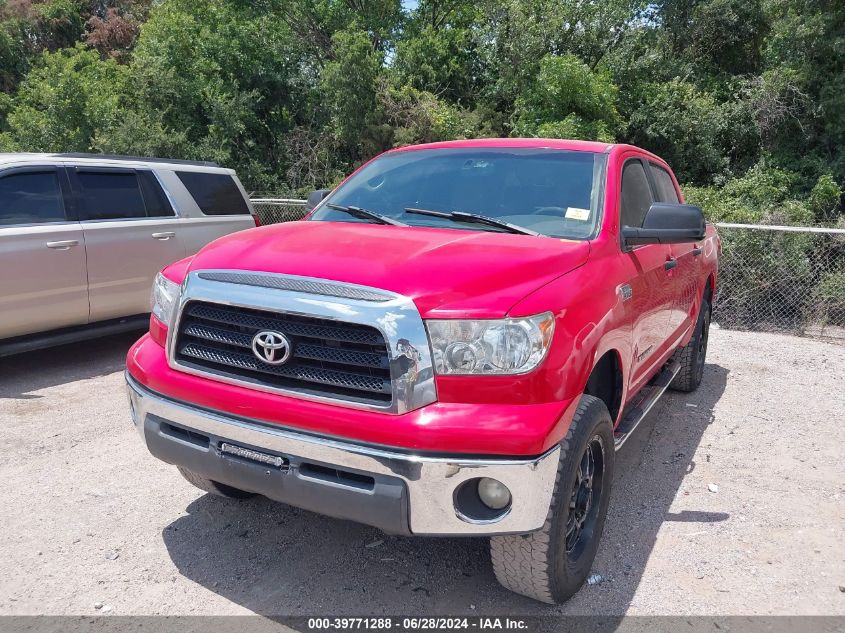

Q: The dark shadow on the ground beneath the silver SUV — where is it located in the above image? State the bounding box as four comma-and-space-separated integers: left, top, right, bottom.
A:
0, 330, 143, 400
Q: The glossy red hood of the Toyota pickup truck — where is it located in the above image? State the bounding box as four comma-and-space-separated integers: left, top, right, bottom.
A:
189, 221, 590, 318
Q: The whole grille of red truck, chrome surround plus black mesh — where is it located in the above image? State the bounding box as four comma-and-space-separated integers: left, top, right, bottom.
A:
167, 269, 437, 414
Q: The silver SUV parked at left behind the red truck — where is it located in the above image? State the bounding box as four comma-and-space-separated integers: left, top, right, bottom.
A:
0, 154, 257, 356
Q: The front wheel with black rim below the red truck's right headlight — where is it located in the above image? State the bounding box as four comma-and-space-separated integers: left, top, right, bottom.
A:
490, 395, 614, 604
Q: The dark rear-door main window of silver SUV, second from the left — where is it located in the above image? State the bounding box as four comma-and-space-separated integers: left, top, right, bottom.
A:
76, 169, 147, 220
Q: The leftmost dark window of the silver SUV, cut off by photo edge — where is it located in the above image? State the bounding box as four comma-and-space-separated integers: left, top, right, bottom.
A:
0, 169, 65, 226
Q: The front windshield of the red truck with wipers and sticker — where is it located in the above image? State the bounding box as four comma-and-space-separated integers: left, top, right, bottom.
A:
311, 148, 606, 239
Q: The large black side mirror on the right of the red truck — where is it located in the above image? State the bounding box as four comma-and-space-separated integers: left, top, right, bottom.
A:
622, 202, 707, 246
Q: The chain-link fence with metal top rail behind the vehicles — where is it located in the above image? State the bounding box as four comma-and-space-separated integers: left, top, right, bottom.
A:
247, 198, 845, 340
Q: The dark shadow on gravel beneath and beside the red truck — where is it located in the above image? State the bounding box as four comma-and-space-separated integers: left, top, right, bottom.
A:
162, 364, 729, 616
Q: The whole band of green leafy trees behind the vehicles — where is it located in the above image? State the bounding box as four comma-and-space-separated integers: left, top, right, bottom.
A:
0, 0, 845, 222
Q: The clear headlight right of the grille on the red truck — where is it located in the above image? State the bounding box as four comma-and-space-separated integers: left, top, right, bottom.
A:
426, 312, 555, 374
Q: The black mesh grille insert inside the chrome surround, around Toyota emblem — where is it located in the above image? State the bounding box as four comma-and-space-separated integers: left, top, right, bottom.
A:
175, 301, 392, 405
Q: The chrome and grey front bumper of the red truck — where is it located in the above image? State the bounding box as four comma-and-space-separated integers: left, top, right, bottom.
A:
126, 374, 560, 536
